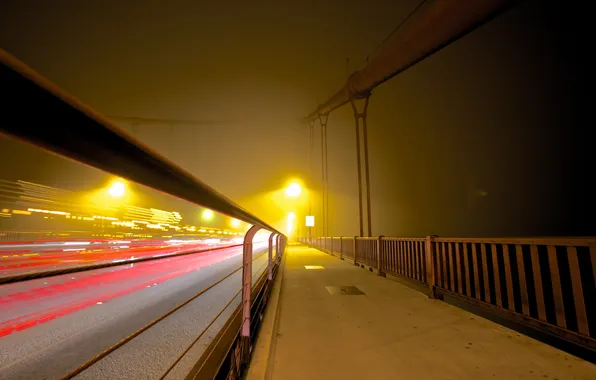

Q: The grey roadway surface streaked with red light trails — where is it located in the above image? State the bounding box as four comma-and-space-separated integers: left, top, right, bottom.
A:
0, 242, 267, 379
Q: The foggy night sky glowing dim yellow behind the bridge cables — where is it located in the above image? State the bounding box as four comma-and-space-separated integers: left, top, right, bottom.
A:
0, 0, 596, 236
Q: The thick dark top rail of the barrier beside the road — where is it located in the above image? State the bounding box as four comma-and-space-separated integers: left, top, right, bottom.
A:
0, 49, 281, 234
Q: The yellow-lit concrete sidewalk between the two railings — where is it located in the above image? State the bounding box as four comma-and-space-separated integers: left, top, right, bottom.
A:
247, 246, 596, 380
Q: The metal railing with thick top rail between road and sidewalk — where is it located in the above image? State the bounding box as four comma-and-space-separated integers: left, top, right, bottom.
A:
0, 49, 286, 379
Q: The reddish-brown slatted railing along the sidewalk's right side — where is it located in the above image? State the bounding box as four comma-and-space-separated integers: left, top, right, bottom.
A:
303, 236, 596, 350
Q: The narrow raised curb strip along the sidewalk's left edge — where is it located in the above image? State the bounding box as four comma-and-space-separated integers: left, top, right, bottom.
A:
245, 249, 287, 380
